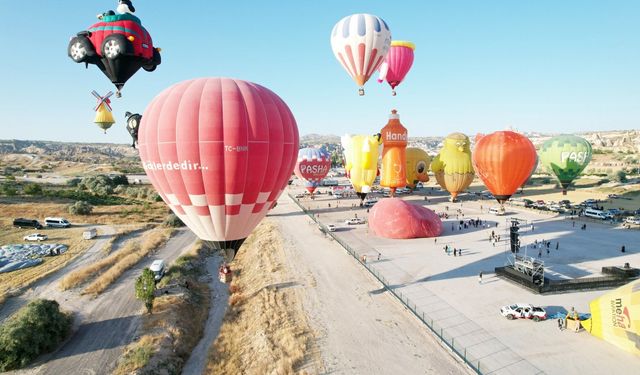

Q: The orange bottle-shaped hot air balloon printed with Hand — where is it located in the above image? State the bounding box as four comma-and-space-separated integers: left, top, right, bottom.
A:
380, 109, 408, 196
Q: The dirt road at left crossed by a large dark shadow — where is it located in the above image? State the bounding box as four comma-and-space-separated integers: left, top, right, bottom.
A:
15, 229, 196, 374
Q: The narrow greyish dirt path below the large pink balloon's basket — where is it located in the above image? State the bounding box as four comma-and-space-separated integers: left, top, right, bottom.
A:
182, 256, 229, 375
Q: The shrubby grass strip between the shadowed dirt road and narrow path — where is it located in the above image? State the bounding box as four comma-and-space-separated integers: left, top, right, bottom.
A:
114, 242, 211, 374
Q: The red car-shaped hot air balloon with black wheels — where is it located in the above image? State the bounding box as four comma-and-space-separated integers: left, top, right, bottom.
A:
67, 4, 161, 97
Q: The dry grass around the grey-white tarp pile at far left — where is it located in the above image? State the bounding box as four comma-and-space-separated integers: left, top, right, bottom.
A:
0, 226, 93, 304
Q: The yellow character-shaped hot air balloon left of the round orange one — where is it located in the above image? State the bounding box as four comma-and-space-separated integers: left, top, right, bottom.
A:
431, 133, 474, 202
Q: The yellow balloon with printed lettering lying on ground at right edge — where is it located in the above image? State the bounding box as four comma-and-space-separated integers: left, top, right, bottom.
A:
580, 280, 640, 355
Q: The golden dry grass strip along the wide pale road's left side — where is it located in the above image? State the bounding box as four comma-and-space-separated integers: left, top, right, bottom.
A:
207, 220, 312, 374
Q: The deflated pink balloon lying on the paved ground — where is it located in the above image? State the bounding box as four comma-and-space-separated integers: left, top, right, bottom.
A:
369, 198, 442, 239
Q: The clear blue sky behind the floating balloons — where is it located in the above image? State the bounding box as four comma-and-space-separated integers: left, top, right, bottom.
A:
0, 0, 640, 143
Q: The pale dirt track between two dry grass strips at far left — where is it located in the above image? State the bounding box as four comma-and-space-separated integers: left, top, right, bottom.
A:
0, 225, 115, 321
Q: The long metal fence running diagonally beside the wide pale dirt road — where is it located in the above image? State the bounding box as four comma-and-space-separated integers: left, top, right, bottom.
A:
288, 194, 544, 374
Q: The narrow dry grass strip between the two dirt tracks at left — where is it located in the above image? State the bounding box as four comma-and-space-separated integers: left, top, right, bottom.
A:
82, 229, 173, 297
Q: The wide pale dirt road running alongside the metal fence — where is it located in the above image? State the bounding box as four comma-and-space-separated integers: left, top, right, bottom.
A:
271, 195, 468, 374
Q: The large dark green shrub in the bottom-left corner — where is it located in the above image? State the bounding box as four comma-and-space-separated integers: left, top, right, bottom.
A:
0, 299, 73, 371
